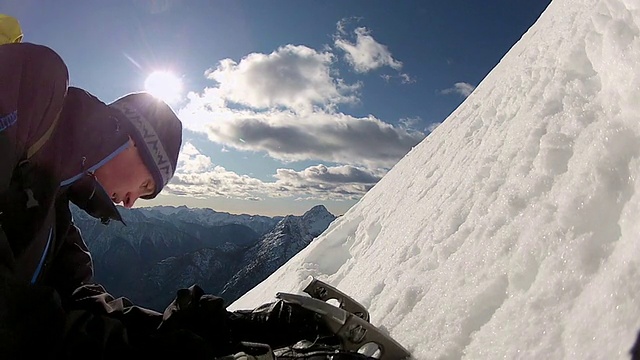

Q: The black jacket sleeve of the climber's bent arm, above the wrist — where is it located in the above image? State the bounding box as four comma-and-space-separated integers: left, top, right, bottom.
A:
35, 196, 162, 358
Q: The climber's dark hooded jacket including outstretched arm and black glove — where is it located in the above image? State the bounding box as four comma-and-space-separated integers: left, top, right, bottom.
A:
0, 43, 330, 360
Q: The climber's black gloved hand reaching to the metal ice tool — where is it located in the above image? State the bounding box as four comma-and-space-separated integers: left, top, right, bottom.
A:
158, 285, 337, 359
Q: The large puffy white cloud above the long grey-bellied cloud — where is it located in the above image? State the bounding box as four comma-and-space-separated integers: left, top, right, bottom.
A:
205, 45, 360, 109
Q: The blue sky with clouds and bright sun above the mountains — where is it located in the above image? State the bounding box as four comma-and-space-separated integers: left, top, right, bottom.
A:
0, 0, 549, 215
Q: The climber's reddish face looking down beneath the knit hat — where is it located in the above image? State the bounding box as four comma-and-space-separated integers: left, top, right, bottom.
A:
95, 140, 155, 208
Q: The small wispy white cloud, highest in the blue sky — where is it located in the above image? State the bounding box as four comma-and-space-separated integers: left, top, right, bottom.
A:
334, 25, 402, 73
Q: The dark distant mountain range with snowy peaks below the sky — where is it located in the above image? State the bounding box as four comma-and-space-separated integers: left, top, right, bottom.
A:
71, 205, 336, 311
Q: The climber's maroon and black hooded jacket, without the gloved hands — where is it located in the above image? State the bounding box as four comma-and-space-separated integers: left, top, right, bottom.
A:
0, 43, 168, 359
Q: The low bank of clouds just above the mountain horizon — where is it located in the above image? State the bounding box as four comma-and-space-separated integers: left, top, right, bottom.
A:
166, 143, 385, 200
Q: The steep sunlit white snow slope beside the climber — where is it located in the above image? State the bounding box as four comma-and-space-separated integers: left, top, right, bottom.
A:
230, 0, 640, 359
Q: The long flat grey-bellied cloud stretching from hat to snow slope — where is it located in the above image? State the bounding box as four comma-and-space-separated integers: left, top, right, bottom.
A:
180, 101, 425, 168
